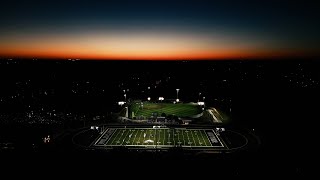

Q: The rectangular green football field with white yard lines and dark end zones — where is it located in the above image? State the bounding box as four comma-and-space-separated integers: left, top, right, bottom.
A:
94, 128, 224, 148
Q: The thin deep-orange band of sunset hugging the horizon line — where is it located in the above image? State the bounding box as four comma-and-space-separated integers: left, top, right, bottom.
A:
1, 48, 302, 60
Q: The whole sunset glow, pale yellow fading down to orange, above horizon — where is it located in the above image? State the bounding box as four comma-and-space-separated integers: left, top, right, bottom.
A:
0, 33, 314, 60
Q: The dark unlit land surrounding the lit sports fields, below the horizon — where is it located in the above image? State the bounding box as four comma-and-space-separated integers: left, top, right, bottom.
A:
0, 60, 320, 176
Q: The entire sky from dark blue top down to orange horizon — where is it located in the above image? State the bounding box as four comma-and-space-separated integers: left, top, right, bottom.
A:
0, 0, 320, 60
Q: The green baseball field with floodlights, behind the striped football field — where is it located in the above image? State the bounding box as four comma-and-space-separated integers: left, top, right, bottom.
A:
131, 102, 201, 117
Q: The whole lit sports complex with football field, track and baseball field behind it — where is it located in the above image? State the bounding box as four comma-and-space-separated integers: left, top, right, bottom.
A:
73, 94, 258, 152
